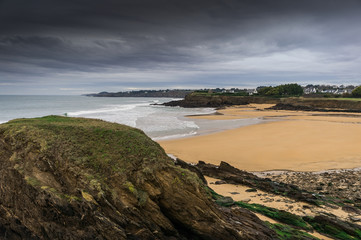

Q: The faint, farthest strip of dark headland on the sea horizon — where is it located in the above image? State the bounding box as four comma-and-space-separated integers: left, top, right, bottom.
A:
85, 90, 192, 98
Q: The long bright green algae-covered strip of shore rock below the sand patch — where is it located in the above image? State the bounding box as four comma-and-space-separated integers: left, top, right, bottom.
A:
235, 201, 312, 230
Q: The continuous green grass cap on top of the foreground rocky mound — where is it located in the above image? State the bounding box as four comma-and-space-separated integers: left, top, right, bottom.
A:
0, 116, 166, 175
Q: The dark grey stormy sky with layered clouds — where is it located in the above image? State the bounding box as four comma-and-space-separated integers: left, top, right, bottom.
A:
0, 0, 361, 95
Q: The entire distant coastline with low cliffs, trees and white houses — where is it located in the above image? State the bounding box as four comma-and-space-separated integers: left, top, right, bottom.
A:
86, 83, 361, 112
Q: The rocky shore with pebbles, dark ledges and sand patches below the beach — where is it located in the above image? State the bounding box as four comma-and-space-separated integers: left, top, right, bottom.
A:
176, 159, 361, 239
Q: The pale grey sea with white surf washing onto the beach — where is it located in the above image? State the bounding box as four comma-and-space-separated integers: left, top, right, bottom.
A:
0, 95, 264, 140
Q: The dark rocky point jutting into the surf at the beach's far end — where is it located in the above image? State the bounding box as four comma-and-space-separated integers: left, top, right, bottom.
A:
164, 93, 279, 108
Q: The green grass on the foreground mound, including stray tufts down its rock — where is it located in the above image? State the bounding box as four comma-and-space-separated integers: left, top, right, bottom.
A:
0, 116, 172, 200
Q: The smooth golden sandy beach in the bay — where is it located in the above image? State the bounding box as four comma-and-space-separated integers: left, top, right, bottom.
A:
159, 104, 361, 171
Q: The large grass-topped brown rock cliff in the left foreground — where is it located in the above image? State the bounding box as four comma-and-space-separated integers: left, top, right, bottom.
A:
0, 116, 274, 240
